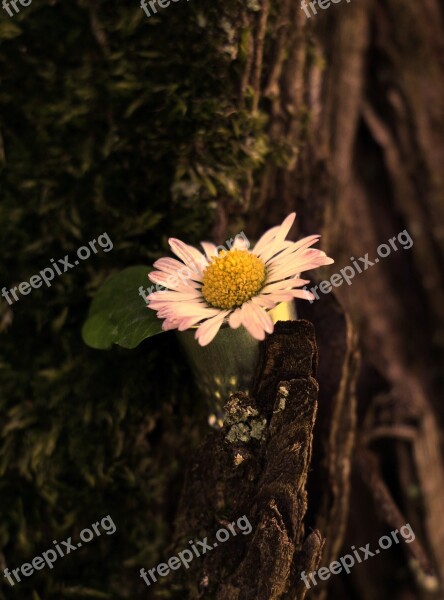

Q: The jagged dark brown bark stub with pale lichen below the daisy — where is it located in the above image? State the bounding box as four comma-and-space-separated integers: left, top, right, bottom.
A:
166, 321, 323, 600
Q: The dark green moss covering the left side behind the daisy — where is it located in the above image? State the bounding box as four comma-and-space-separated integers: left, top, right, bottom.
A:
0, 0, 270, 600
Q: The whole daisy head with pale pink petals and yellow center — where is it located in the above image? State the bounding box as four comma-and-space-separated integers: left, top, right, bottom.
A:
147, 213, 334, 346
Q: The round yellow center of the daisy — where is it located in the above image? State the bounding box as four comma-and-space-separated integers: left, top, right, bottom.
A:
202, 250, 265, 309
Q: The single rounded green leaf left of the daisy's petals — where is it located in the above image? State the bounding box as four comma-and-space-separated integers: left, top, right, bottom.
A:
82, 266, 162, 350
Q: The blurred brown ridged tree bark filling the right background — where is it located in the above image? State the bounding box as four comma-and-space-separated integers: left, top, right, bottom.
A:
207, 0, 444, 600
